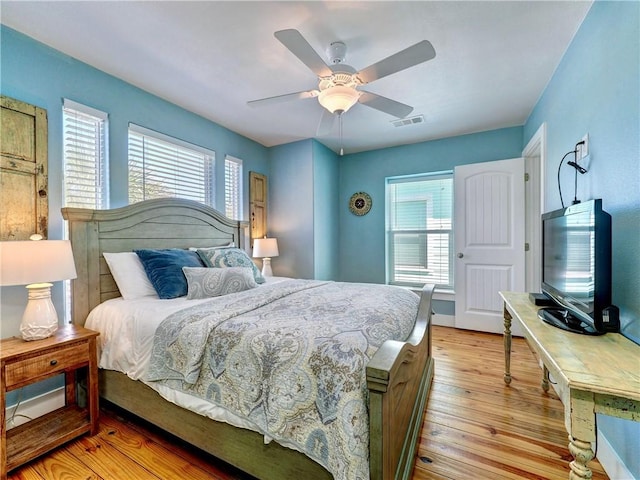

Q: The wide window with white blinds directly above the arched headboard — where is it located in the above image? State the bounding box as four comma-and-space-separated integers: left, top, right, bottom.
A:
129, 124, 215, 207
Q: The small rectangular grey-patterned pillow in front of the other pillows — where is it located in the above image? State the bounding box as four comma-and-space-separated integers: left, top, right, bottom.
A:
182, 267, 258, 300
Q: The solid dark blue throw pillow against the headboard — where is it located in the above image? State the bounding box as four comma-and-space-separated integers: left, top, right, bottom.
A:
134, 248, 203, 298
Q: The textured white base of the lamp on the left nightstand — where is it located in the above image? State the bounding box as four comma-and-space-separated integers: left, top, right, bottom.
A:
20, 283, 58, 341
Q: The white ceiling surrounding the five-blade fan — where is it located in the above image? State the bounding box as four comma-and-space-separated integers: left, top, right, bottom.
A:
0, 0, 592, 153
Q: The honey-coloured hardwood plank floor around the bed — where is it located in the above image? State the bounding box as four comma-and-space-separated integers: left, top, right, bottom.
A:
9, 327, 608, 480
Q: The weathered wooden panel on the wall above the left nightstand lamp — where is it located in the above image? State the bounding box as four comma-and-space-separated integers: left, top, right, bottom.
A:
0, 96, 49, 241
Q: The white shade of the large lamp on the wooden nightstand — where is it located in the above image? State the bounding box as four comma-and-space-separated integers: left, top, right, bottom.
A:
0, 240, 77, 286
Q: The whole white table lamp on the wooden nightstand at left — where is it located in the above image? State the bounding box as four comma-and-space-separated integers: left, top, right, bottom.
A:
0, 235, 77, 340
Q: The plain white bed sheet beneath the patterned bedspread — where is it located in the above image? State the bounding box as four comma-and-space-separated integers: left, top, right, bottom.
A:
85, 277, 293, 438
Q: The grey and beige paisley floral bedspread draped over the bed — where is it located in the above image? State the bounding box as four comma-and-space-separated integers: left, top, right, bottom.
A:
147, 280, 419, 480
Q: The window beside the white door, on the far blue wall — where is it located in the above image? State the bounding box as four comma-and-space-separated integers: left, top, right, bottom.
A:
386, 172, 453, 289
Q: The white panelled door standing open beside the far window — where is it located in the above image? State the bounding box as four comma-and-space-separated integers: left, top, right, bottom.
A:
454, 158, 525, 333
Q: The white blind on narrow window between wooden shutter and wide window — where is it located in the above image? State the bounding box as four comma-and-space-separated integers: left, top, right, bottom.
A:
62, 99, 109, 209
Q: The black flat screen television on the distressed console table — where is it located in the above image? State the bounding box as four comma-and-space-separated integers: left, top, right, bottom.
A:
538, 199, 619, 335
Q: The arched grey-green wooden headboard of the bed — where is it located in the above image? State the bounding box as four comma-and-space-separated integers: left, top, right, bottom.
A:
62, 198, 248, 325
